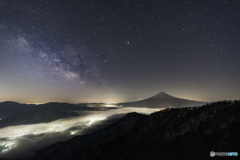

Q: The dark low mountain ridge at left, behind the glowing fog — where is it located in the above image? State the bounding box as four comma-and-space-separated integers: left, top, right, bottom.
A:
0, 102, 97, 128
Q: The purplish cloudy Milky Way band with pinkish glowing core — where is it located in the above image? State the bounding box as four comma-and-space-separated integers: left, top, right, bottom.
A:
15, 37, 101, 85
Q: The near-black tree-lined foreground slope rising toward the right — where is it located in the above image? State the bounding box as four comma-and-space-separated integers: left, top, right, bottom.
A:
34, 101, 240, 160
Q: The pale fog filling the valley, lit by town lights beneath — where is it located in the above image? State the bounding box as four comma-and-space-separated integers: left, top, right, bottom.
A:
0, 107, 161, 158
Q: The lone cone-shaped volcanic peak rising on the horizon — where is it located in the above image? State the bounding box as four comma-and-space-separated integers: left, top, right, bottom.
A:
118, 92, 207, 108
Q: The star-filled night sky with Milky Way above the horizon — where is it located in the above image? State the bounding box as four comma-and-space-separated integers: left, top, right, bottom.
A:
0, 0, 240, 103
